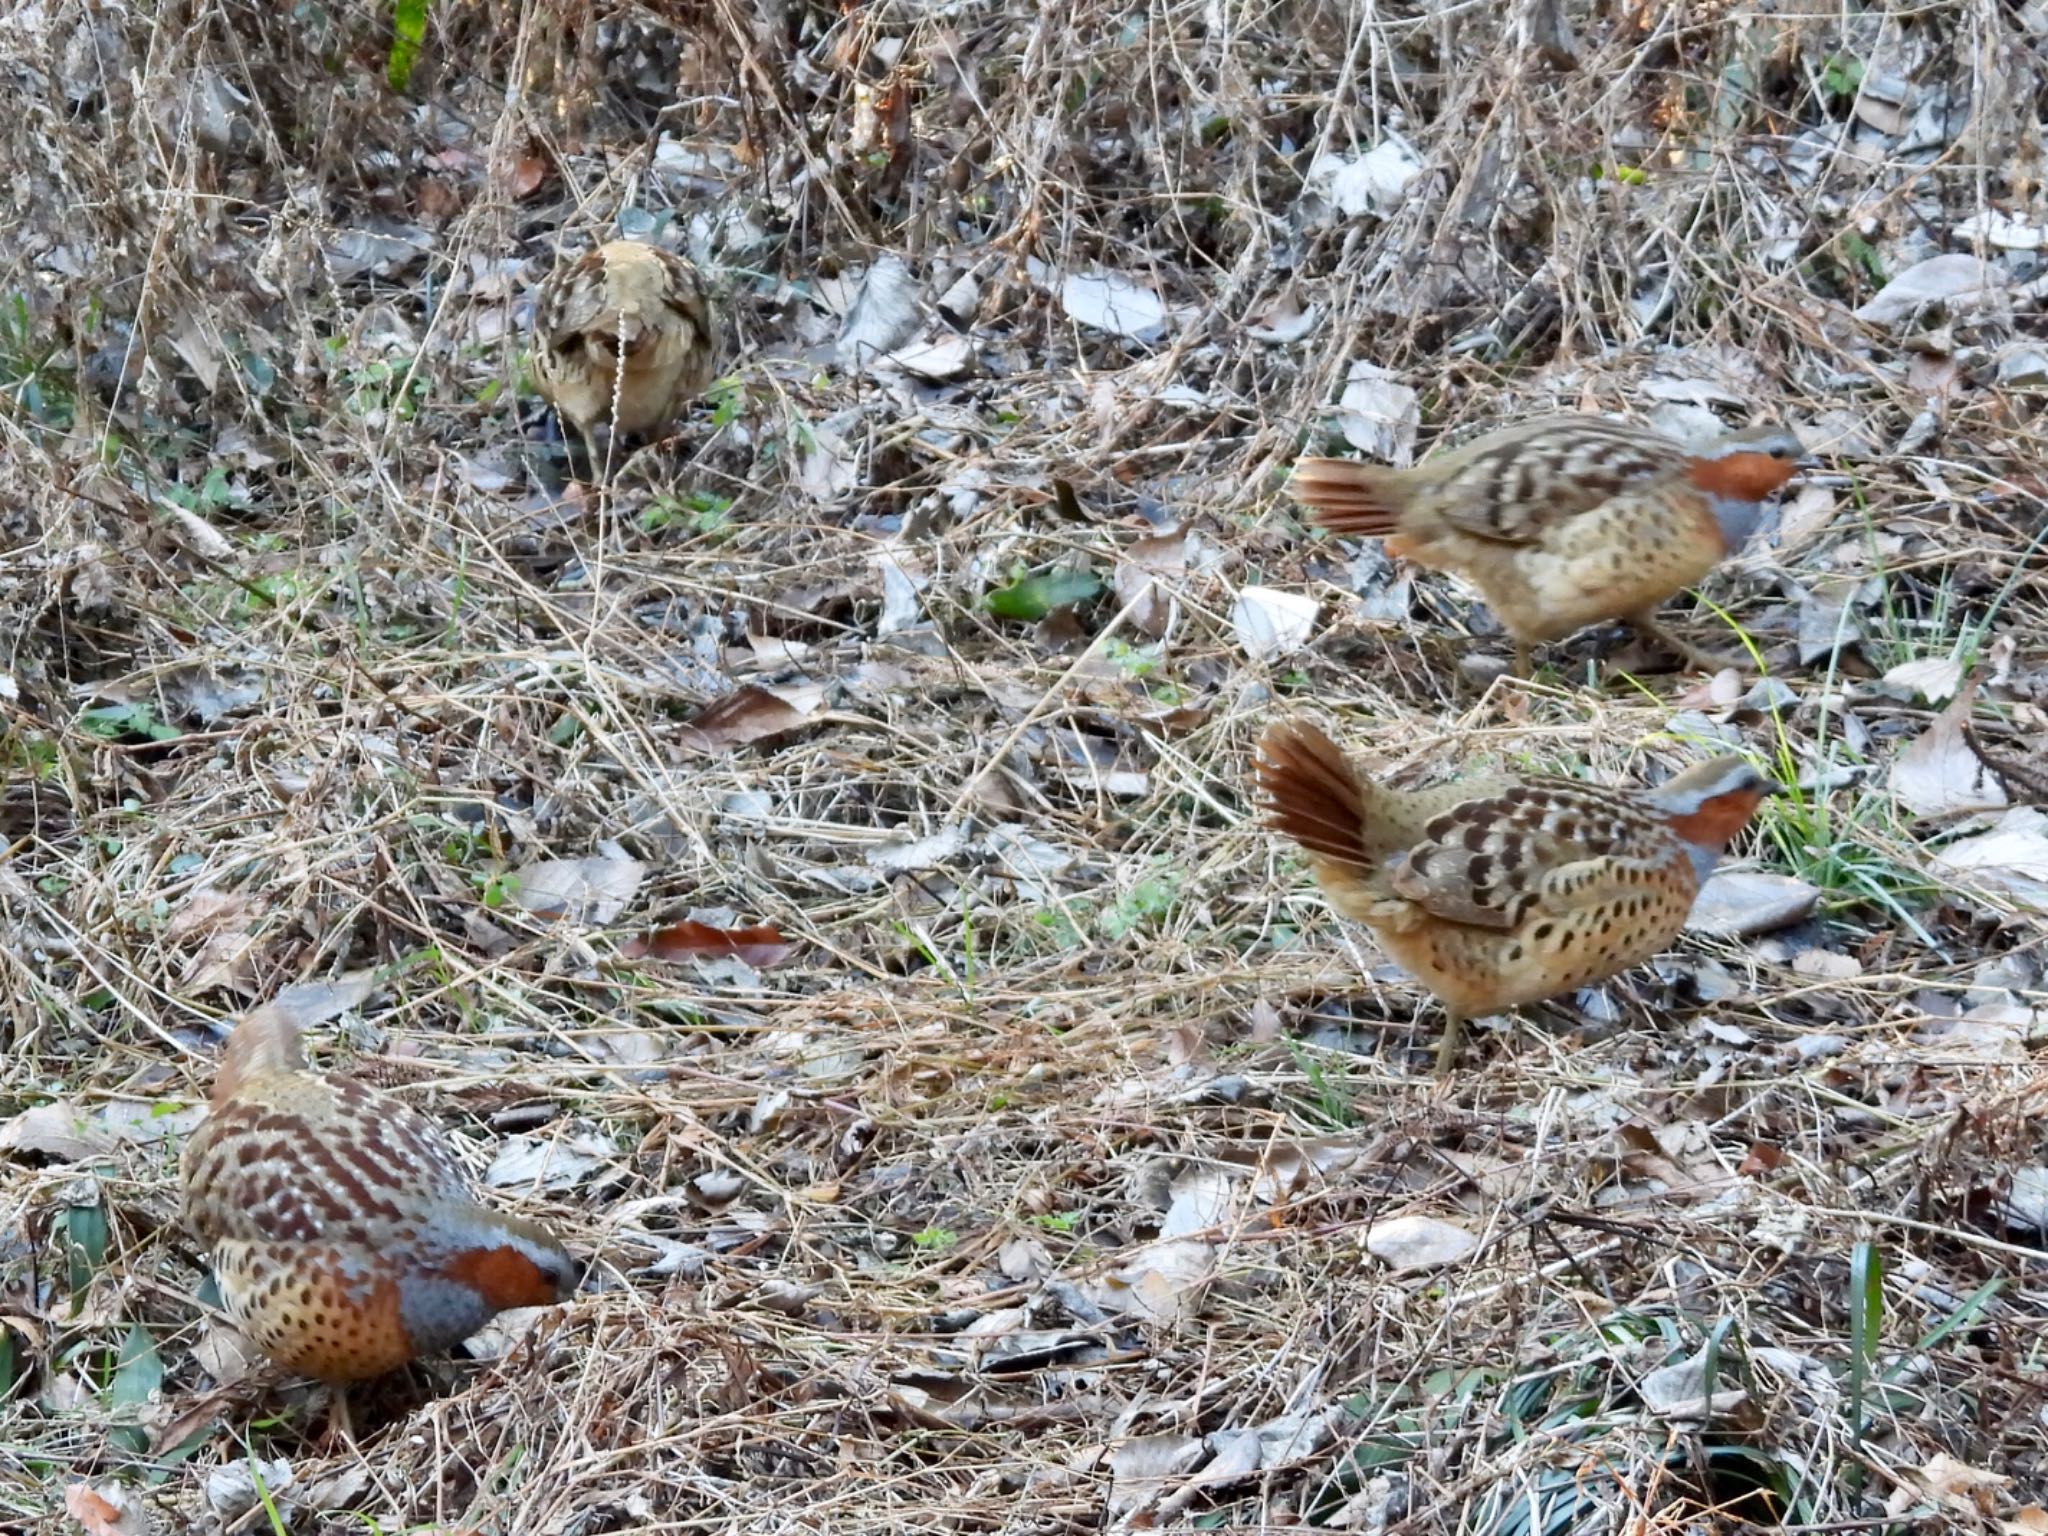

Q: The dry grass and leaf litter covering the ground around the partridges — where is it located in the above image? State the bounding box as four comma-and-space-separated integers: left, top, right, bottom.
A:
0, 0, 2048, 1536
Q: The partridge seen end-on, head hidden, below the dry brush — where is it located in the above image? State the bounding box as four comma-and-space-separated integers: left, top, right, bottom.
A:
532, 240, 719, 473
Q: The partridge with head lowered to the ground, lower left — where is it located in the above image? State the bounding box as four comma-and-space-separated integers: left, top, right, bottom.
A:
180, 1008, 578, 1382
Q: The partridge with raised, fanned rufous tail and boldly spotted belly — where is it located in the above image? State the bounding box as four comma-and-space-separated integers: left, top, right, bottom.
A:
1257, 721, 1778, 1071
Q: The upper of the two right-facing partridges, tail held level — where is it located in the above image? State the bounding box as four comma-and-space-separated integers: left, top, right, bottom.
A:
1290, 416, 1804, 678
